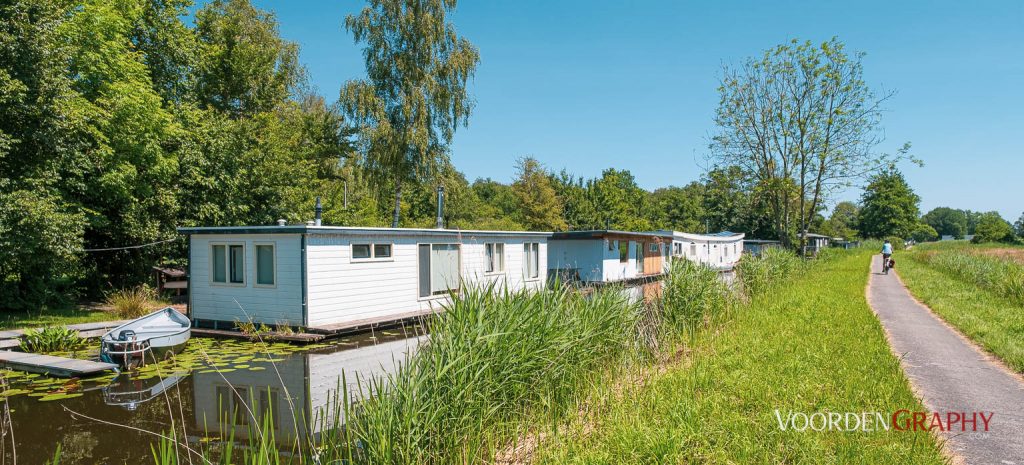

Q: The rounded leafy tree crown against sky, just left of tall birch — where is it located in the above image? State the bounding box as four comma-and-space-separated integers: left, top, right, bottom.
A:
196, 0, 304, 118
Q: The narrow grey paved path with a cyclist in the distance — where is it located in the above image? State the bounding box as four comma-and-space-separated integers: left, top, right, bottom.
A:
867, 255, 1024, 465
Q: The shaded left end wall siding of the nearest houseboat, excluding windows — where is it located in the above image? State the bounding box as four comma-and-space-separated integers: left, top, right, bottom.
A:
188, 234, 305, 326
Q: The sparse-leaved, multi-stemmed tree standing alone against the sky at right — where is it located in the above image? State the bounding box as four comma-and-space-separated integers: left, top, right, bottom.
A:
711, 38, 908, 250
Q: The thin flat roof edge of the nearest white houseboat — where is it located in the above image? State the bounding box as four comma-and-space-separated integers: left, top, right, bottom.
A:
177, 224, 551, 238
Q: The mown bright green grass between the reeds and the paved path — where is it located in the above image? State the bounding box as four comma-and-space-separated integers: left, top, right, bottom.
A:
538, 251, 945, 464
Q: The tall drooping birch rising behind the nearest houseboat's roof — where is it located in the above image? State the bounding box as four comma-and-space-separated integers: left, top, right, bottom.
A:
341, 0, 479, 227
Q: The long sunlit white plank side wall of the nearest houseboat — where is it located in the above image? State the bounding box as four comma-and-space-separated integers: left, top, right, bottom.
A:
306, 234, 547, 326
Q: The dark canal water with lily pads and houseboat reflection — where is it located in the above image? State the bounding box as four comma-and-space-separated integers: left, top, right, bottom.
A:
0, 327, 423, 465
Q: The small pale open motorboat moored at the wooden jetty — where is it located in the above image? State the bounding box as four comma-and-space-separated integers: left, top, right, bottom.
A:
99, 307, 191, 369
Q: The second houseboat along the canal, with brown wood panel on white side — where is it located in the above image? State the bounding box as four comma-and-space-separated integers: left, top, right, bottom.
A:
548, 229, 672, 284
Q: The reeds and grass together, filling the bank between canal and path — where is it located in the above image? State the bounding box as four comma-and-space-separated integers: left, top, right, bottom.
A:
46, 249, 944, 465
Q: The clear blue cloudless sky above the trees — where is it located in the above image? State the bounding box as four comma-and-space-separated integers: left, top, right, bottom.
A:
237, 0, 1024, 221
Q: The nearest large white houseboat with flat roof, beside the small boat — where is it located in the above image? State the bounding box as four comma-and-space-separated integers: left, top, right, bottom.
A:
178, 224, 551, 333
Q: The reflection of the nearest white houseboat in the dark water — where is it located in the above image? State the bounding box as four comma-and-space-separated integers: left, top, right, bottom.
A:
193, 338, 420, 442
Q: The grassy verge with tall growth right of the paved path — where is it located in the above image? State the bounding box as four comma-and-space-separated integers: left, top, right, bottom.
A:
897, 244, 1024, 373
